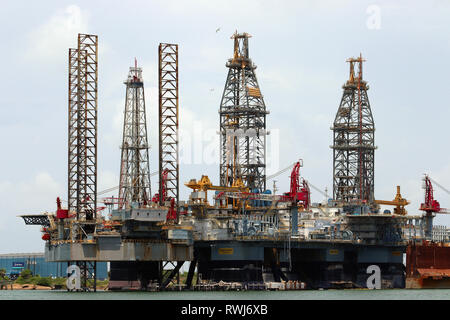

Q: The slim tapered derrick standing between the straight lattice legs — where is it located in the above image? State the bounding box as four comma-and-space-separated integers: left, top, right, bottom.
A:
119, 61, 151, 209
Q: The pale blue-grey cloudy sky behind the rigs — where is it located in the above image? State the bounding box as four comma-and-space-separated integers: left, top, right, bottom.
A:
0, 0, 450, 253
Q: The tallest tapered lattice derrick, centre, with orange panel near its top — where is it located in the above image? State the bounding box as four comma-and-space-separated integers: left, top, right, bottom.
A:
219, 32, 268, 191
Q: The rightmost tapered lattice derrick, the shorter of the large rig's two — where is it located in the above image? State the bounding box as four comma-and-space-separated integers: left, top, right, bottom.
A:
331, 56, 376, 204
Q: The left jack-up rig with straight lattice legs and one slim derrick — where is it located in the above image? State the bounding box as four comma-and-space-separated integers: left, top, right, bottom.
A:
22, 34, 193, 290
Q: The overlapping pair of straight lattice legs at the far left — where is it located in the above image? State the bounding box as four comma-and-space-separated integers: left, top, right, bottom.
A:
68, 34, 98, 222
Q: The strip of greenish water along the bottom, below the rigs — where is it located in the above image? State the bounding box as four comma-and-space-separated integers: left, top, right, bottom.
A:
0, 289, 450, 300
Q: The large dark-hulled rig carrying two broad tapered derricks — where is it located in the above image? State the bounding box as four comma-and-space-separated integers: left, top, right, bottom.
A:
177, 33, 405, 288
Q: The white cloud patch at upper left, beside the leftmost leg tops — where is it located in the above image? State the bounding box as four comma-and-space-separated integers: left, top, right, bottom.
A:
25, 5, 88, 61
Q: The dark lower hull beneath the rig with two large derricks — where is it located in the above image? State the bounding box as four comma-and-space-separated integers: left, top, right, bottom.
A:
194, 241, 406, 289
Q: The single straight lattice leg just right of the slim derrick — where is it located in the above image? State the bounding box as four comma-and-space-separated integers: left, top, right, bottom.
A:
158, 43, 179, 207
